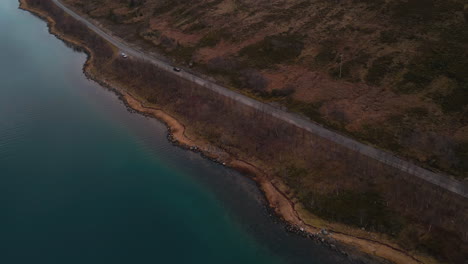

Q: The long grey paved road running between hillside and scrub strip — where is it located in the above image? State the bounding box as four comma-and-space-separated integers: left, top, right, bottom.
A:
52, 0, 468, 198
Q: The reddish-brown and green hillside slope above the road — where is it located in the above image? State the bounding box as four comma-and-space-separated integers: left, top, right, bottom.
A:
65, 0, 468, 179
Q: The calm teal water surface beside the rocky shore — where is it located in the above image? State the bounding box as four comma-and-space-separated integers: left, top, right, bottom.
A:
0, 0, 354, 264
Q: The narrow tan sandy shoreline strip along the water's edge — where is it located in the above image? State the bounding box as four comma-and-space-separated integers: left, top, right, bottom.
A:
19, 0, 433, 263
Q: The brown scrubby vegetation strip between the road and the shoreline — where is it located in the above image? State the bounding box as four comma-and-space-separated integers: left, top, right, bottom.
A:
26, 0, 468, 263
